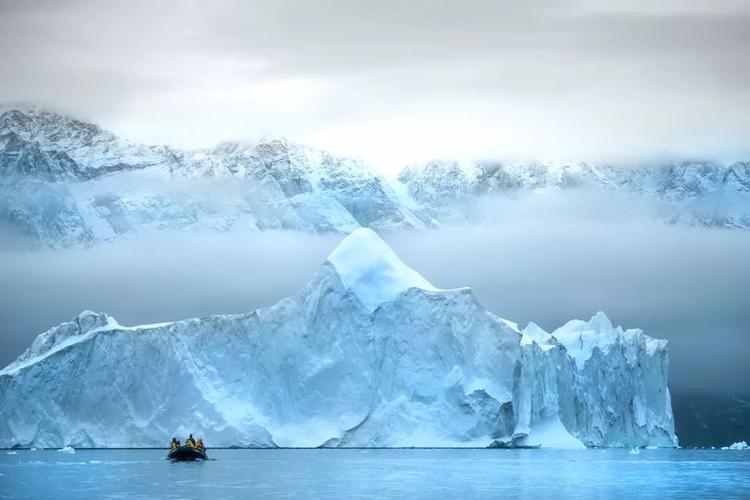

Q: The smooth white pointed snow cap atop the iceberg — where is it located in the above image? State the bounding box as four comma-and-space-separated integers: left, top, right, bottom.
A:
328, 228, 439, 312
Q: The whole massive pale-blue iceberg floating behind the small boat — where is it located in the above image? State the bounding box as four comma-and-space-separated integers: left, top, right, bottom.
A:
0, 228, 677, 447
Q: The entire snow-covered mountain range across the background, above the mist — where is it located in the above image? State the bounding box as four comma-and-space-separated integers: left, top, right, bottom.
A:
0, 106, 750, 247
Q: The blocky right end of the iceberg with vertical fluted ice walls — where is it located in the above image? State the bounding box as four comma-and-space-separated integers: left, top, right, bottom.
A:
514, 312, 677, 447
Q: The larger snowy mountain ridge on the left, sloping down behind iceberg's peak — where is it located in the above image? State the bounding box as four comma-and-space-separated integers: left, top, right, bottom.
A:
0, 107, 423, 247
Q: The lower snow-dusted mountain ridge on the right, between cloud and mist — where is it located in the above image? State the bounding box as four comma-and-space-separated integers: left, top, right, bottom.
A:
399, 161, 750, 229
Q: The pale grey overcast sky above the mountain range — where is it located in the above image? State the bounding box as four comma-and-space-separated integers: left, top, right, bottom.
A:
0, 0, 750, 170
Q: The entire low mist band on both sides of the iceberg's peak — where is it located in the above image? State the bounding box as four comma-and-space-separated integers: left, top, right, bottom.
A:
0, 198, 750, 392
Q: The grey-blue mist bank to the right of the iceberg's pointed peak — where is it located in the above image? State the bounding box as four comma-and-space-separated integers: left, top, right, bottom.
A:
392, 211, 750, 393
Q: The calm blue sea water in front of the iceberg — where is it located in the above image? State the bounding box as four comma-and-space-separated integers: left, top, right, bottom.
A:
0, 449, 750, 500
